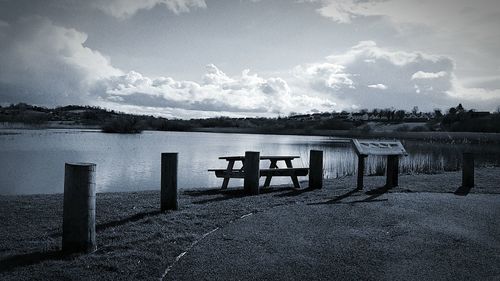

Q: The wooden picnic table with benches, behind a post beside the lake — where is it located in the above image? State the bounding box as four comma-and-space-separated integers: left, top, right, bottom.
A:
208, 156, 309, 189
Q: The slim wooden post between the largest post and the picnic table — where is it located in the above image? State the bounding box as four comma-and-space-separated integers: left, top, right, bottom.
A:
160, 153, 178, 212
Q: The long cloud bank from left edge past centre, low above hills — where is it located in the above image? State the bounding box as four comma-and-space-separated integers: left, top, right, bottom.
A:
0, 17, 332, 117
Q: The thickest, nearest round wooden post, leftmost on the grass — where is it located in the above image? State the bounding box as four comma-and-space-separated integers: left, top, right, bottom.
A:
62, 163, 97, 253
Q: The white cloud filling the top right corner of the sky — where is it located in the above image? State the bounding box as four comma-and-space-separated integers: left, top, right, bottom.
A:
308, 0, 500, 94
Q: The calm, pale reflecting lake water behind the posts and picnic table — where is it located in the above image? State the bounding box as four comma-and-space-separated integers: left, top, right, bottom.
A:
0, 130, 500, 195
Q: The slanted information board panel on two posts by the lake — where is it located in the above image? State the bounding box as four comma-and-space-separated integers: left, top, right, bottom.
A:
352, 139, 408, 156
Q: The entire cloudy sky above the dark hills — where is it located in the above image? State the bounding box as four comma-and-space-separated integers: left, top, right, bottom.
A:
0, 0, 500, 118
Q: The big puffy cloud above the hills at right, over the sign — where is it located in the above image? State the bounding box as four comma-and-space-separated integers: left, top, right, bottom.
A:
292, 41, 500, 110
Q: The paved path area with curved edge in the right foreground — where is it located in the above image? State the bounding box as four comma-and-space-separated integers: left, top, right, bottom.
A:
165, 193, 500, 280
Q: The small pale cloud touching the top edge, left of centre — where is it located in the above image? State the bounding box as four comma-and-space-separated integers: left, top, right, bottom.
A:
93, 0, 207, 19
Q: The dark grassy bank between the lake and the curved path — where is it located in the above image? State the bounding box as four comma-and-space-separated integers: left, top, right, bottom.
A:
0, 167, 500, 280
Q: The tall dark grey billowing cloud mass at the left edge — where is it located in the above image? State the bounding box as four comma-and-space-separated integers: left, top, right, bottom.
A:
0, 17, 122, 105
